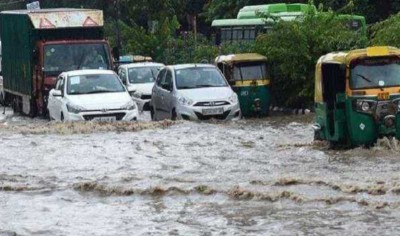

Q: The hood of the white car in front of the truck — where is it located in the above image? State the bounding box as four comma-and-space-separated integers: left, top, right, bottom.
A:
68, 92, 132, 110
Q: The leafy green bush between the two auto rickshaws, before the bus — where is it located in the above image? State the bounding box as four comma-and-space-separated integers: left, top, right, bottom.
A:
257, 6, 367, 106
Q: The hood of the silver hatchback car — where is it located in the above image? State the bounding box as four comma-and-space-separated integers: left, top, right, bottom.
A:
178, 87, 233, 101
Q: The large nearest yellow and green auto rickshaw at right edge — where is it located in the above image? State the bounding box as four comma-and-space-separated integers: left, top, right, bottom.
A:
314, 47, 400, 146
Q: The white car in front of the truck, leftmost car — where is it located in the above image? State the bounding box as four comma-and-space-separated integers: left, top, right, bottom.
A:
47, 70, 138, 122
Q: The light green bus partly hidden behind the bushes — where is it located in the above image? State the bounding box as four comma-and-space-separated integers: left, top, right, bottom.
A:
211, 3, 367, 45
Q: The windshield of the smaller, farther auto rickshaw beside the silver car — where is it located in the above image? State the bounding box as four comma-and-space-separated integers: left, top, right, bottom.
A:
233, 62, 269, 80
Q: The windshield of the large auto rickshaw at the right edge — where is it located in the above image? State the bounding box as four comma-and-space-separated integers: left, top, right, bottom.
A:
350, 57, 400, 89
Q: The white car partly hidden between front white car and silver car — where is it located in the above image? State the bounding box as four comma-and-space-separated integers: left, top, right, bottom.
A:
118, 62, 164, 111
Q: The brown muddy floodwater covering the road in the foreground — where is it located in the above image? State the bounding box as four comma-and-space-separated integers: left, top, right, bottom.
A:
0, 108, 400, 236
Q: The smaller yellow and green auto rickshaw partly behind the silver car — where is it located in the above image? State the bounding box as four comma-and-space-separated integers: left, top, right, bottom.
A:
215, 53, 271, 117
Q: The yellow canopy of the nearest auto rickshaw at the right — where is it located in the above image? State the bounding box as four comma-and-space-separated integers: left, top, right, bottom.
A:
314, 46, 400, 102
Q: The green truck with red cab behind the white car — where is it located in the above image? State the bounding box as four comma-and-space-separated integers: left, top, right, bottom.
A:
0, 9, 113, 116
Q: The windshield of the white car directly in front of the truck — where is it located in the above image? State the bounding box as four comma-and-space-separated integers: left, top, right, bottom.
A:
67, 74, 125, 95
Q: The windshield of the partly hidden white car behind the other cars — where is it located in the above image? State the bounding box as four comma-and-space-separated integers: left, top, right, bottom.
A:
128, 66, 160, 84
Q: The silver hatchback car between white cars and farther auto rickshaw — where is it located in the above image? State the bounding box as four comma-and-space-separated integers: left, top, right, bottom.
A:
150, 64, 241, 120
